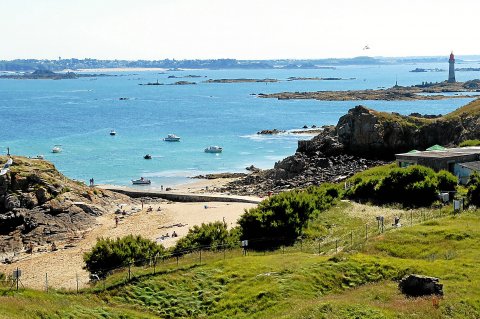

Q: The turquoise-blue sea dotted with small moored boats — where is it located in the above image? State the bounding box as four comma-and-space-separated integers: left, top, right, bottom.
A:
0, 62, 480, 189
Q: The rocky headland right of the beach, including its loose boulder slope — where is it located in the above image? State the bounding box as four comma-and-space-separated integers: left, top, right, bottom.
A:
222, 99, 480, 195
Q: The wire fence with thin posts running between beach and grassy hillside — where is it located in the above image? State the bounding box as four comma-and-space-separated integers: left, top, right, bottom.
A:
0, 206, 451, 293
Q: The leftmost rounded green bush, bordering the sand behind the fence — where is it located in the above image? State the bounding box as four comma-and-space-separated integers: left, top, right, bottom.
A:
83, 235, 165, 277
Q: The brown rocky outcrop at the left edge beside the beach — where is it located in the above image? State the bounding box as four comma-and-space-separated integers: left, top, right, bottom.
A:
0, 156, 128, 254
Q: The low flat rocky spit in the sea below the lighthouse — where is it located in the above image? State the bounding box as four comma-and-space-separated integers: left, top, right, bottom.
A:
257, 80, 480, 101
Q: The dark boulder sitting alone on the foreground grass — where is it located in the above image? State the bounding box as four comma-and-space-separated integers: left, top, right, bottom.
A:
398, 274, 443, 297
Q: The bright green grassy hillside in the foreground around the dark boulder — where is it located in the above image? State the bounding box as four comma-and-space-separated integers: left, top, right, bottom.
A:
0, 202, 480, 318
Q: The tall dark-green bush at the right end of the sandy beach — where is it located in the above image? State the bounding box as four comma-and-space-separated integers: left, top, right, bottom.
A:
238, 184, 340, 249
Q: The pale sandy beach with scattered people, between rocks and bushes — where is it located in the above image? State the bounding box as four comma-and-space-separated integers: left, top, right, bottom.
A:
0, 180, 258, 289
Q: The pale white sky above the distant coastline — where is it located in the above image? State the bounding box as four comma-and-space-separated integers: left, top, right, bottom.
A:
0, 0, 480, 60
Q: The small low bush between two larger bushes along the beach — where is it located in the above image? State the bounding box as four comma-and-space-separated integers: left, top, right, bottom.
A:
173, 222, 240, 256
